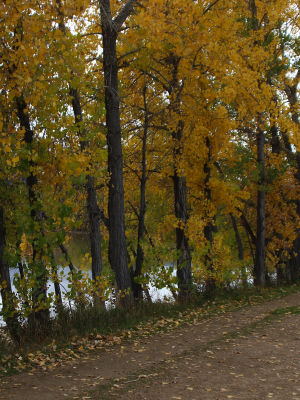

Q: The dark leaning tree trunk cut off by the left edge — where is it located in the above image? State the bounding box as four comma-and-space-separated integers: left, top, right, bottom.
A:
0, 206, 22, 343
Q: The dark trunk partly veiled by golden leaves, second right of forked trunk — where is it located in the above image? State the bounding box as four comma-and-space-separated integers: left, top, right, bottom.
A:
167, 54, 192, 301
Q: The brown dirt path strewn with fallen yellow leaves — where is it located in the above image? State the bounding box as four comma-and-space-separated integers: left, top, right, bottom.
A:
0, 293, 300, 400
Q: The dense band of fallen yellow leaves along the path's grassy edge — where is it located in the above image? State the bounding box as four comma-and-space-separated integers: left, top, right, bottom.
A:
0, 288, 298, 376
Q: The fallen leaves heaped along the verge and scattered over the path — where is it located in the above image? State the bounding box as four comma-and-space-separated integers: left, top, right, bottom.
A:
0, 286, 298, 398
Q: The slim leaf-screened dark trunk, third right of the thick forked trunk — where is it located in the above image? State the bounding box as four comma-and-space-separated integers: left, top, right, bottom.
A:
204, 137, 216, 292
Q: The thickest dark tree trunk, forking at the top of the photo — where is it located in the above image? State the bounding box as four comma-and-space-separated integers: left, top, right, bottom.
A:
99, 0, 136, 304
